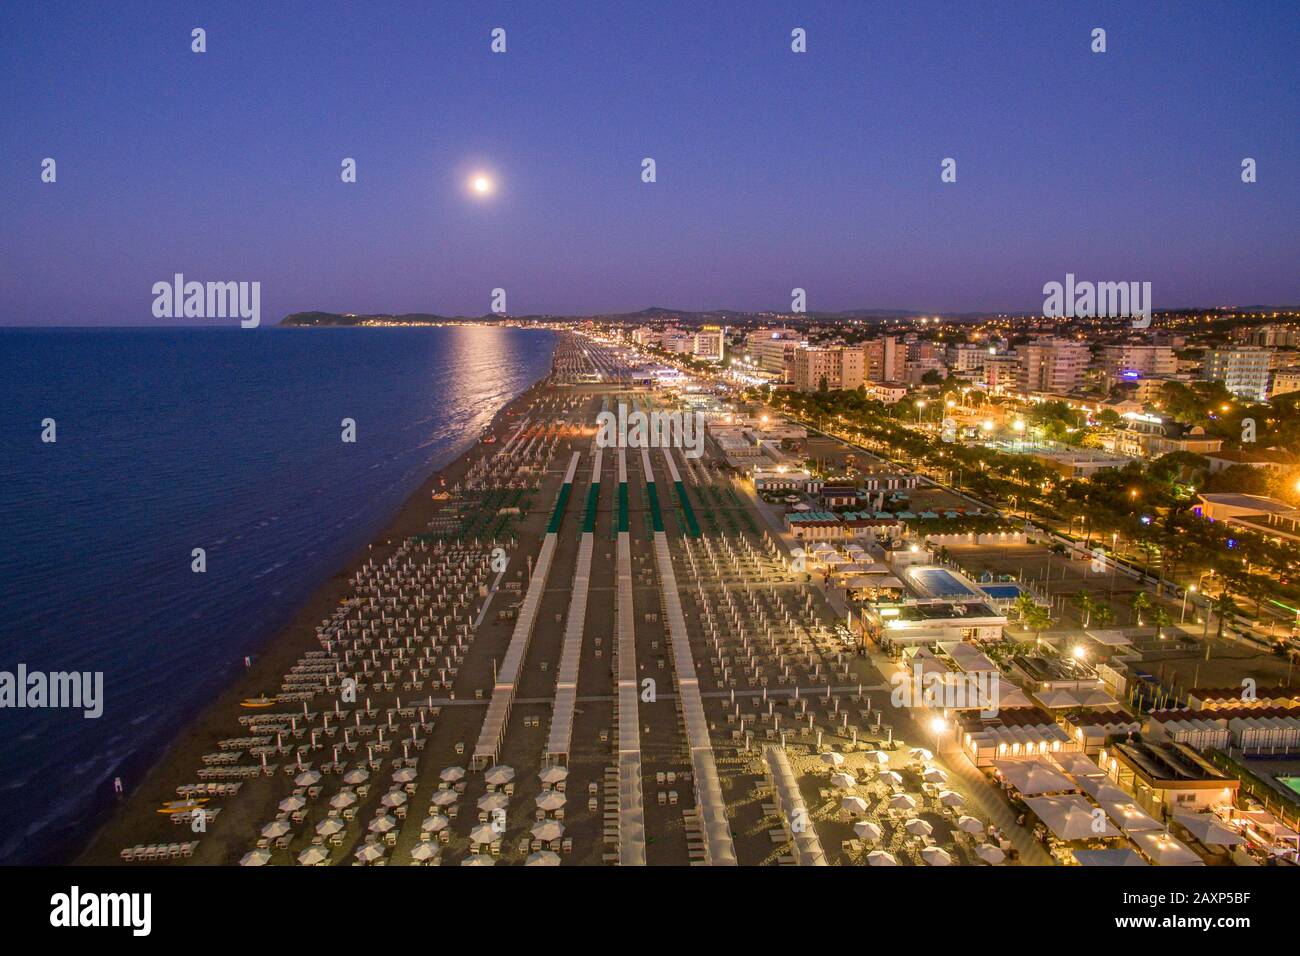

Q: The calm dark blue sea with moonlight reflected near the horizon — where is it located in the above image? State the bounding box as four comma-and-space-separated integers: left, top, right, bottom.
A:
0, 328, 554, 862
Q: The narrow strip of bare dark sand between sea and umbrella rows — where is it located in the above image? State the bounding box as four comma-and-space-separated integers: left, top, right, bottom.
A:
74, 351, 558, 866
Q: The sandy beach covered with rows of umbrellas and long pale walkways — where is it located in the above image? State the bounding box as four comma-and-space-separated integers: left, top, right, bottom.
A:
92, 337, 1032, 865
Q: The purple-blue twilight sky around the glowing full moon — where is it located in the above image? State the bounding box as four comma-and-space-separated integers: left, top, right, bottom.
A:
0, 0, 1300, 325
